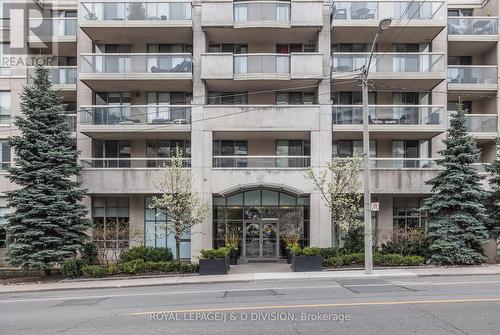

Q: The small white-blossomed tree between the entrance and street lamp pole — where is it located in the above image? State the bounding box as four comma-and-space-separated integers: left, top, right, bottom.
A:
306, 156, 362, 254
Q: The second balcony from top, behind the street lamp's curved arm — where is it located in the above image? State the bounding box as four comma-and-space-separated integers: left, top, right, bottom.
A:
332, 52, 446, 89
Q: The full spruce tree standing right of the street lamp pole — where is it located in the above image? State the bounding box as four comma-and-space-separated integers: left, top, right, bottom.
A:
422, 102, 488, 264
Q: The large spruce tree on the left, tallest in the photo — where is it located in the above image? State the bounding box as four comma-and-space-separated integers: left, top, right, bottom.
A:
7, 68, 90, 274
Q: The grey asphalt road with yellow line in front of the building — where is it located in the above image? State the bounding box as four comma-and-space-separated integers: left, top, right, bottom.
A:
0, 276, 500, 335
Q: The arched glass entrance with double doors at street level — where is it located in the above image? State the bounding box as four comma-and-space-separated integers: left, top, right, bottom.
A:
213, 185, 309, 260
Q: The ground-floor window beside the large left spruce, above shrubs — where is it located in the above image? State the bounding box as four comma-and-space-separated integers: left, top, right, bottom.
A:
92, 197, 130, 248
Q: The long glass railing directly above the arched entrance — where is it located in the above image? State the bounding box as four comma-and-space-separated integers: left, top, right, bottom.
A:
213, 156, 311, 169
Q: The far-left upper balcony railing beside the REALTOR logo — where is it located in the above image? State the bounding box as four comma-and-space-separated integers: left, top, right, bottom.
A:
28, 17, 77, 47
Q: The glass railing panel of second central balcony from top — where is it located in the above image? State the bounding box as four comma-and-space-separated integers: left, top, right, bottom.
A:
234, 54, 290, 74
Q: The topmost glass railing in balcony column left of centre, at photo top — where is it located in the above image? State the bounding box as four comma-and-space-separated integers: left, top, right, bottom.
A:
80, 1, 191, 21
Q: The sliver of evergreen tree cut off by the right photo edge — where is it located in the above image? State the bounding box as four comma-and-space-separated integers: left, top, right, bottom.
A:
486, 138, 500, 247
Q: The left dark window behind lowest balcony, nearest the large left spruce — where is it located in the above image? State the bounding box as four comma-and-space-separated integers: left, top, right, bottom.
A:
92, 140, 132, 168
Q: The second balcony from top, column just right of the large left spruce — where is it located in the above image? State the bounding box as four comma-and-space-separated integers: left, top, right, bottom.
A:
79, 53, 192, 91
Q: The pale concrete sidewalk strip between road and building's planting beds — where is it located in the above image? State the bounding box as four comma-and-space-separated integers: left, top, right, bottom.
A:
0, 265, 500, 293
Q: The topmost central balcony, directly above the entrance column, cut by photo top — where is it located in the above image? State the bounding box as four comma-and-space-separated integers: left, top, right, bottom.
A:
201, 1, 323, 28
